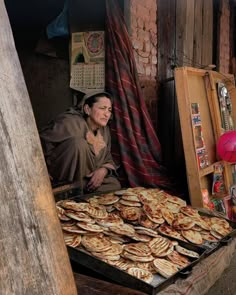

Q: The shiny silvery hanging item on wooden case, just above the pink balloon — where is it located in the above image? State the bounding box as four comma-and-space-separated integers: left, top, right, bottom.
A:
217, 83, 234, 131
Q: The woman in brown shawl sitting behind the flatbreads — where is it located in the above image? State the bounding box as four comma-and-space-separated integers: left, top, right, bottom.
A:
40, 92, 120, 192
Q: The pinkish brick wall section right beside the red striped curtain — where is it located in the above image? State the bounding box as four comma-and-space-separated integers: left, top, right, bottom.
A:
129, 0, 157, 127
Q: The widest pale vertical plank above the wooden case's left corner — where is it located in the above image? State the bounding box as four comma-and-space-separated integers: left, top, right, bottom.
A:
176, 0, 194, 66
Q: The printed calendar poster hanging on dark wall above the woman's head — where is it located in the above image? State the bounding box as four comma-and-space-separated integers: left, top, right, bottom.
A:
70, 31, 105, 93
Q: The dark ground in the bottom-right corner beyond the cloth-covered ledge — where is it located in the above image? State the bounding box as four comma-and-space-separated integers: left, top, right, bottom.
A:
206, 252, 236, 295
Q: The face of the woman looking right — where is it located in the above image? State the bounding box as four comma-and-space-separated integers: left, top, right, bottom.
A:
84, 96, 112, 130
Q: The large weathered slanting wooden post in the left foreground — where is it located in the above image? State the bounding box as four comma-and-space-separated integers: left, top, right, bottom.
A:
0, 0, 77, 295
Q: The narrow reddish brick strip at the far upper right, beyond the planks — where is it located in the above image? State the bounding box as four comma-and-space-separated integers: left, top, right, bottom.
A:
219, 0, 230, 73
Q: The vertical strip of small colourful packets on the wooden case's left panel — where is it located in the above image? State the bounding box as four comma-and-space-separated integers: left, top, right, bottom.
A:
191, 103, 209, 169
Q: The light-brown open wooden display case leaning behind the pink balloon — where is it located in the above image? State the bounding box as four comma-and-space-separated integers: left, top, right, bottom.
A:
175, 67, 236, 207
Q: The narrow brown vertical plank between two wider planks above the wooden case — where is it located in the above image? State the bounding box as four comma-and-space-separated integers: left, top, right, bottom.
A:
193, 0, 203, 68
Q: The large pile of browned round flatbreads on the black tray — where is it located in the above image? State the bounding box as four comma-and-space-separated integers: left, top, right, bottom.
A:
56, 187, 232, 283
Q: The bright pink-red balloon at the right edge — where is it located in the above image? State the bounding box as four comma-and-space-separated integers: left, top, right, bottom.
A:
216, 131, 236, 163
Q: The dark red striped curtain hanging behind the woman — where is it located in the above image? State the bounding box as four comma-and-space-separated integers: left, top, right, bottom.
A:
106, 0, 170, 187
